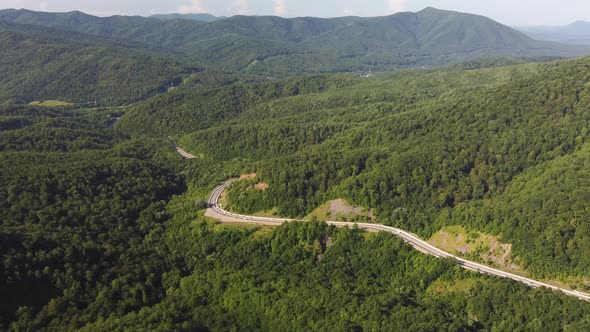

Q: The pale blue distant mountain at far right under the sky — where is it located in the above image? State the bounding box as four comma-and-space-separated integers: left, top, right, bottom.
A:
518, 21, 590, 45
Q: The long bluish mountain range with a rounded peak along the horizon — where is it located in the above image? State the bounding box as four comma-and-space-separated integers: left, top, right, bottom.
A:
0, 8, 590, 76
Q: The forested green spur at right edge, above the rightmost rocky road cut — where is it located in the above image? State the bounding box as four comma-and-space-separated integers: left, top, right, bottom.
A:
445, 143, 590, 276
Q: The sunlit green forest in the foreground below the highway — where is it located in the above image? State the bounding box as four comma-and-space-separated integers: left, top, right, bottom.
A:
78, 223, 590, 331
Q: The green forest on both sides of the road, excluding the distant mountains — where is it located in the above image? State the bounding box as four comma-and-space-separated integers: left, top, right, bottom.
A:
0, 59, 590, 331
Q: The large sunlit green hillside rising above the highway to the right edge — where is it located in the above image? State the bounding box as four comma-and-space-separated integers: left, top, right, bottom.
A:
114, 58, 590, 286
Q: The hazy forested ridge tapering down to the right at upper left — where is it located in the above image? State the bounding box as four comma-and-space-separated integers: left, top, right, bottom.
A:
0, 22, 192, 105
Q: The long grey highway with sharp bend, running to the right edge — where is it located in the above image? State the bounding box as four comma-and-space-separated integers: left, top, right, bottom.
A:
205, 180, 590, 301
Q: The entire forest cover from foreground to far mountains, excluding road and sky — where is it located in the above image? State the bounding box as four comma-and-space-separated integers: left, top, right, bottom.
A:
0, 9, 590, 331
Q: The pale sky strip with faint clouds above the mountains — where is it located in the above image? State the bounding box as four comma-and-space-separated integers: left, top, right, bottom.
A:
0, 0, 590, 25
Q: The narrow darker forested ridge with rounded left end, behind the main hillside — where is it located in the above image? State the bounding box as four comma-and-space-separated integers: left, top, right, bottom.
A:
117, 75, 354, 136
